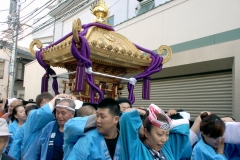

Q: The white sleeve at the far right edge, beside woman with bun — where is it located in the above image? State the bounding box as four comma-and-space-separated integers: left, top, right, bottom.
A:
223, 122, 240, 144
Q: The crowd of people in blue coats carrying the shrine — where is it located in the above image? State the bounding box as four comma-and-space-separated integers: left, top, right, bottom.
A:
0, 92, 240, 160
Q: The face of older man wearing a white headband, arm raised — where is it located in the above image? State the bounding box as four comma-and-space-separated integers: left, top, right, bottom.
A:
56, 102, 74, 126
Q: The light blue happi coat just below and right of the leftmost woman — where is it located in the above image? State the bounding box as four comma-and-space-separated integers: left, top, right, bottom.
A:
8, 124, 25, 160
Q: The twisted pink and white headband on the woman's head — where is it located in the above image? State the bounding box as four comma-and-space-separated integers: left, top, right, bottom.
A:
148, 104, 172, 130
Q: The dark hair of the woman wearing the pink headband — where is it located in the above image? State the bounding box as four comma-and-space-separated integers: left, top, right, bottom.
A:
143, 111, 169, 132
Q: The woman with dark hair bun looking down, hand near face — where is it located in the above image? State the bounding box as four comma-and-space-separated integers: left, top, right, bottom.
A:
191, 112, 240, 160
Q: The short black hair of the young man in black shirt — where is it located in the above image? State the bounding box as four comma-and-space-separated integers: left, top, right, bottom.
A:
98, 98, 120, 116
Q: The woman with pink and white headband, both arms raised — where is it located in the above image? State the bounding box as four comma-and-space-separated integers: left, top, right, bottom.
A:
120, 104, 189, 160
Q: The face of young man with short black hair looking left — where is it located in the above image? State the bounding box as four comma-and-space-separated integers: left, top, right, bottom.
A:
96, 108, 119, 135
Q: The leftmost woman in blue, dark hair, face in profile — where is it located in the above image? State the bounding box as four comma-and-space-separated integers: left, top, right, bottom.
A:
8, 105, 27, 149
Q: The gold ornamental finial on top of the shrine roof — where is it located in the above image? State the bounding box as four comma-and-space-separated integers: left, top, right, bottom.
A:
90, 0, 109, 22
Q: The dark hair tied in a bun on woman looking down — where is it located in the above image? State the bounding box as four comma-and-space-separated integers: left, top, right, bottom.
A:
200, 112, 226, 137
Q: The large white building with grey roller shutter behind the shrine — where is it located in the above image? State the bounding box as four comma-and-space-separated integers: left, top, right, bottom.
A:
24, 0, 240, 121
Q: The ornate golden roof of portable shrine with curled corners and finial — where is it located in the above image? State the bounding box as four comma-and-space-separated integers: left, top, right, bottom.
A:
30, 0, 172, 75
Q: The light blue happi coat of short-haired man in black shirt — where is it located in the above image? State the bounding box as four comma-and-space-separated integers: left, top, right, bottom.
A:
67, 129, 120, 160
